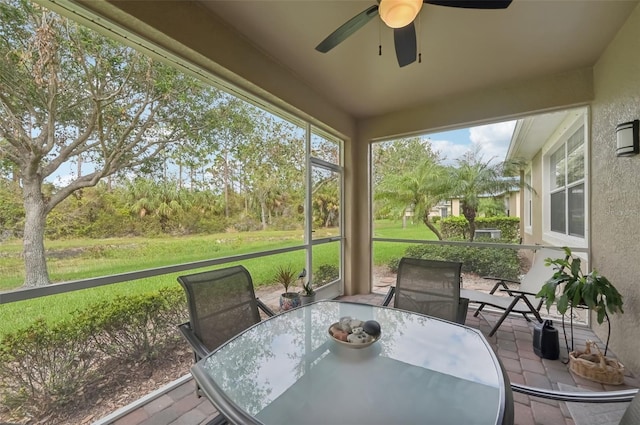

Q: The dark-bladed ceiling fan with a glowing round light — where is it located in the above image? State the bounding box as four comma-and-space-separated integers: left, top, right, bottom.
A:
316, 0, 512, 67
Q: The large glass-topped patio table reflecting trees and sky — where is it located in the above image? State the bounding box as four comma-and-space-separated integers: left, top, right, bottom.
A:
191, 301, 513, 425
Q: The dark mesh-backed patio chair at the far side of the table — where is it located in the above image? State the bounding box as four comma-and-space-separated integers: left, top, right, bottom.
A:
382, 257, 469, 324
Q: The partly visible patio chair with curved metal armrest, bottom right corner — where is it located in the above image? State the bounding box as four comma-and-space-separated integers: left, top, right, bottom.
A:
511, 384, 640, 425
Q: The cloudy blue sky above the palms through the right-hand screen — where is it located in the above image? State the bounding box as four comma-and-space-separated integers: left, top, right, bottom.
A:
424, 121, 516, 165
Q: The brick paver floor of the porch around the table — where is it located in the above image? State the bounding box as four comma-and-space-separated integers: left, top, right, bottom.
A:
97, 285, 639, 425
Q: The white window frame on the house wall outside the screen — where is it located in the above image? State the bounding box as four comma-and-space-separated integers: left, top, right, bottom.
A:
542, 109, 590, 248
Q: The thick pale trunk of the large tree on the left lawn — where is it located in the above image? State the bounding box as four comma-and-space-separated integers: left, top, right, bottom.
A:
23, 180, 50, 287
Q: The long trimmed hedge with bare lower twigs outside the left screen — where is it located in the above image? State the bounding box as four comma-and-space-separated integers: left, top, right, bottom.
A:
0, 286, 187, 413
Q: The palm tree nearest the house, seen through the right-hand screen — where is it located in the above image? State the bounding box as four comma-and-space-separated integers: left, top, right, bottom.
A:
449, 149, 518, 241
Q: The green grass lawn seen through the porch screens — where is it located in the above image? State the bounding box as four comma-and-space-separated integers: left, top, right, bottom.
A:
0, 221, 435, 336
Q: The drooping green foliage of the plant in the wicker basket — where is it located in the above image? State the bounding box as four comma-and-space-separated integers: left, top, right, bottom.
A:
536, 247, 624, 324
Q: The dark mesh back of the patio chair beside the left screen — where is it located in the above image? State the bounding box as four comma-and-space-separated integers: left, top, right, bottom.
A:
178, 266, 260, 351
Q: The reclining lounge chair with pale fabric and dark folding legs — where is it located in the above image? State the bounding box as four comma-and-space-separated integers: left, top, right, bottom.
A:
460, 248, 564, 336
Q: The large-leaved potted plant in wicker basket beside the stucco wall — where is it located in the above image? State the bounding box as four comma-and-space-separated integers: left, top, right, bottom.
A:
537, 247, 624, 384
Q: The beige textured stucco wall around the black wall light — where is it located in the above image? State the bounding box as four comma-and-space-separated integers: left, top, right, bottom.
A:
590, 3, 640, 373
